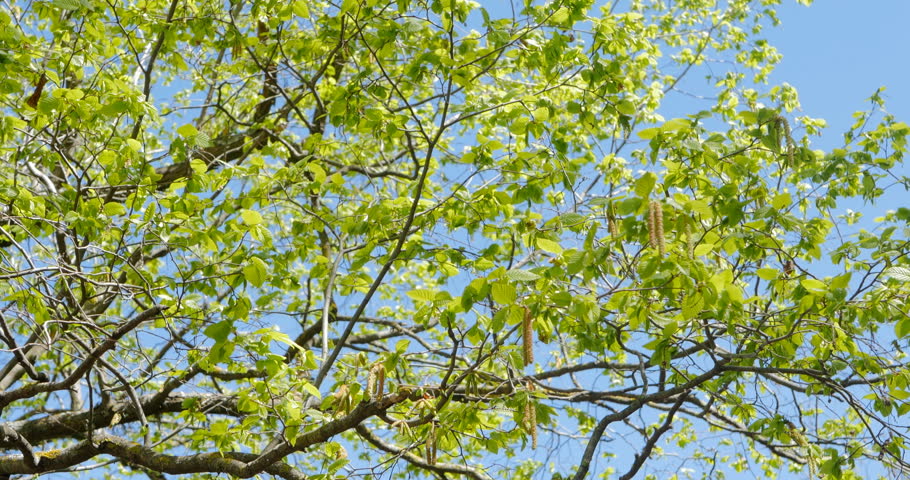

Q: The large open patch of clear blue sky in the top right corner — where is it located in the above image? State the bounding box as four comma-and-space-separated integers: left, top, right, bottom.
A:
765, 0, 910, 149
